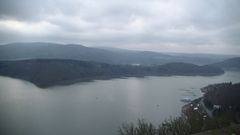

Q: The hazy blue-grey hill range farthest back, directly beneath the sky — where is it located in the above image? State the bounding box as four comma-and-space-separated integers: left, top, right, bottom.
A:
0, 42, 234, 65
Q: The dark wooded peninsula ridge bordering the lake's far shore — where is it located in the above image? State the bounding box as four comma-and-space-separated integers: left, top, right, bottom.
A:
0, 59, 224, 87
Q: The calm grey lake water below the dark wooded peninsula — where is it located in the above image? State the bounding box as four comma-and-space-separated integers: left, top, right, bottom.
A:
0, 72, 240, 135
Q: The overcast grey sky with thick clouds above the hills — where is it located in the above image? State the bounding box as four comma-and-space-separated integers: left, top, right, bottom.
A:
0, 0, 240, 54
